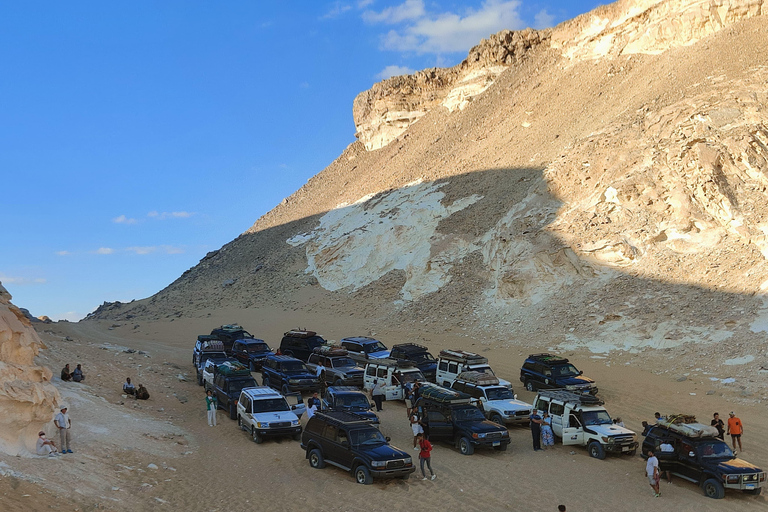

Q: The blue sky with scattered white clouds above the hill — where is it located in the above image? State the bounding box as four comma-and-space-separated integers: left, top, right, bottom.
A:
0, 0, 600, 320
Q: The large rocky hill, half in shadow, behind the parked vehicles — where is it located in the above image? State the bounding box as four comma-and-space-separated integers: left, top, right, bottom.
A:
92, 0, 768, 394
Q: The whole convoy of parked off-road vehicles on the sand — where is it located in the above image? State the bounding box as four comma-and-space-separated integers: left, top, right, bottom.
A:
192, 325, 766, 498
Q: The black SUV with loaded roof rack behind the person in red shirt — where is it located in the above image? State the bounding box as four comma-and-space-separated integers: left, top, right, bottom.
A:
416, 384, 509, 455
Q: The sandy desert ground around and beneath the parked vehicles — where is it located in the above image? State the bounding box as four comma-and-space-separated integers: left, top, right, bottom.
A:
0, 308, 768, 511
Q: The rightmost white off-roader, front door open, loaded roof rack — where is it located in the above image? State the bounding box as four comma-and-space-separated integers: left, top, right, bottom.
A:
533, 390, 638, 459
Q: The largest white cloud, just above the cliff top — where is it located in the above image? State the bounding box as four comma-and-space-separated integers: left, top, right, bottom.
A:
376, 0, 525, 54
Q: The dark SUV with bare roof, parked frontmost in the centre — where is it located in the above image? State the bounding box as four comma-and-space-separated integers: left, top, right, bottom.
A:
301, 411, 416, 484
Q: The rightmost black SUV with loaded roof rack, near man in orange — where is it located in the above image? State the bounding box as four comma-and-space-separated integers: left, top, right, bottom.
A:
643, 424, 766, 498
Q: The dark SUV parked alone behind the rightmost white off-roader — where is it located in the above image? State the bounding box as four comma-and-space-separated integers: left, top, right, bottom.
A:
520, 354, 597, 395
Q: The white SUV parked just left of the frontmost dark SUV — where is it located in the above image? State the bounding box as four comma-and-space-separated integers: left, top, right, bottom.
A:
237, 386, 306, 444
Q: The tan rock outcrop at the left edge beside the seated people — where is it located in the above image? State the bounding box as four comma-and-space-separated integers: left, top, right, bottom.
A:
0, 285, 59, 455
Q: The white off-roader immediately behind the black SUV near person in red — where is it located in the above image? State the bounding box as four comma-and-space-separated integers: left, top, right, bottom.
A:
451, 372, 533, 425
